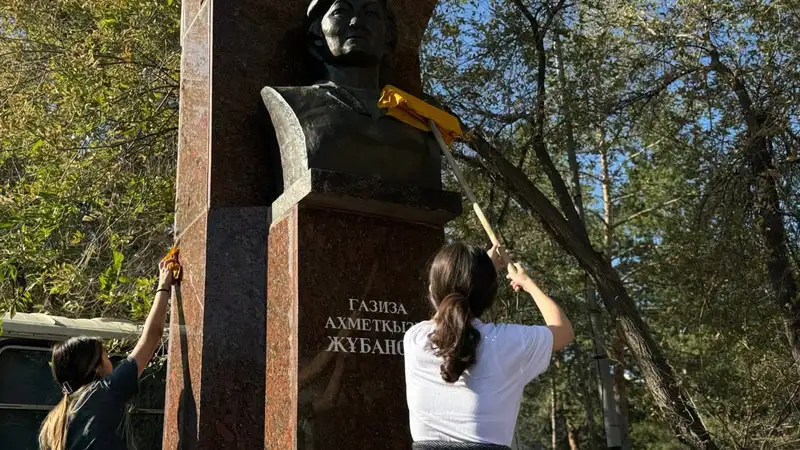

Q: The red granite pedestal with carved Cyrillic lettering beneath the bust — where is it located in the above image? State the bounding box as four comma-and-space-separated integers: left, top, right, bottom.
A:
265, 173, 460, 450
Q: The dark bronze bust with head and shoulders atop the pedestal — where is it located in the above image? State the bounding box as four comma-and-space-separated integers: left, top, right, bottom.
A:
261, 0, 441, 195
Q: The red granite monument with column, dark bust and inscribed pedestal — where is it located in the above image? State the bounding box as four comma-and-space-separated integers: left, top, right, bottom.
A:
164, 0, 461, 450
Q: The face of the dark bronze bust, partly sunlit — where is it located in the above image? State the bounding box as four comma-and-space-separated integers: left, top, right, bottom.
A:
322, 0, 387, 67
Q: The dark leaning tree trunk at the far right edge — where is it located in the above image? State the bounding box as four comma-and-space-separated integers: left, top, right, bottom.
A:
710, 51, 800, 372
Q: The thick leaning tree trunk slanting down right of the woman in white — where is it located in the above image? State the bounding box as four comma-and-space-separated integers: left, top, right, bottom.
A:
469, 133, 717, 450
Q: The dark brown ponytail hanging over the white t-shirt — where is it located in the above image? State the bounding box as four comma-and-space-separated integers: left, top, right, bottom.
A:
430, 293, 481, 383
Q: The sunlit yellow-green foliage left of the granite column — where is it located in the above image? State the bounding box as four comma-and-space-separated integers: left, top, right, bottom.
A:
0, 0, 180, 319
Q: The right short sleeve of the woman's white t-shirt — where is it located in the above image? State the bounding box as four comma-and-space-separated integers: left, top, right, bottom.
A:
501, 325, 553, 383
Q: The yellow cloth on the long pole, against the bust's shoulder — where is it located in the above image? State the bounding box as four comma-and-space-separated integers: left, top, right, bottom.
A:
378, 85, 464, 145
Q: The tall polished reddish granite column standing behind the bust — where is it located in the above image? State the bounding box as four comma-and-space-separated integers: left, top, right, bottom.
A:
164, 0, 440, 449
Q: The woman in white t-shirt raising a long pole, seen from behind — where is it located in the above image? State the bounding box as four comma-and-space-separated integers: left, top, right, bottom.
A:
403, 243, 574, 450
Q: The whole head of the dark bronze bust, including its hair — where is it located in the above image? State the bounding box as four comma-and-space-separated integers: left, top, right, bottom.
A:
308, 0, 397, 67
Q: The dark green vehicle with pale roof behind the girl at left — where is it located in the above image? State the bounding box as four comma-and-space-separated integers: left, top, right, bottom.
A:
0, 313, 166, 450
